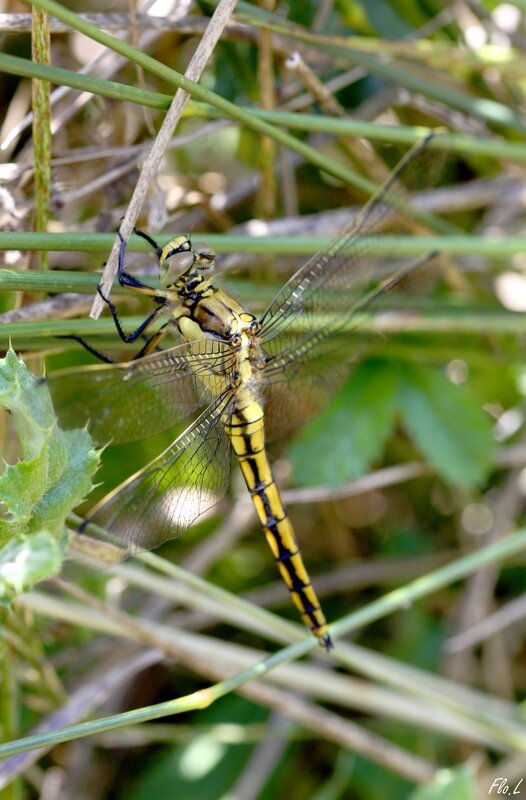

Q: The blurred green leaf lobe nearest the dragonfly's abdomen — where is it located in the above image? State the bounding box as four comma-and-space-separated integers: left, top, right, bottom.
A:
289, 359, 398, 487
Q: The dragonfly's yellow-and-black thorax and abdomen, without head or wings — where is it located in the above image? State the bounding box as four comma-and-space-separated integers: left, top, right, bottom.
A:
161, 250, 332, 650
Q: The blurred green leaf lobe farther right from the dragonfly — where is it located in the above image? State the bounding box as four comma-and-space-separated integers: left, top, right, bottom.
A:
400, 364, 494, 487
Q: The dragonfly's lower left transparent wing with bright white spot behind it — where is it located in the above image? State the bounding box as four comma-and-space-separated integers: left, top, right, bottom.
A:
83, 391, 234, 553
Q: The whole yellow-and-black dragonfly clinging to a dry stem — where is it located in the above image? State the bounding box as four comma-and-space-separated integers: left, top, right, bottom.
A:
47, 141, 442, 651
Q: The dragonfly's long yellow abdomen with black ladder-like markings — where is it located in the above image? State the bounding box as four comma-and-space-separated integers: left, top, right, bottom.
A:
225, 392, 332, 650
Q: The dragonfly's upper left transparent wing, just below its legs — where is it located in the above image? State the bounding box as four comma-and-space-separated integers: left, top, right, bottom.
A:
46, 339, 235, 444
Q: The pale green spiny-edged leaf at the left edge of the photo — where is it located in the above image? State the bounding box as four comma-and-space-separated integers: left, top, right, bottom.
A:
0, 350, 100, 602
